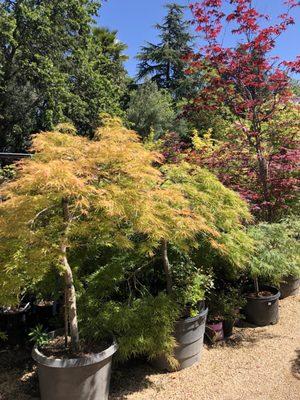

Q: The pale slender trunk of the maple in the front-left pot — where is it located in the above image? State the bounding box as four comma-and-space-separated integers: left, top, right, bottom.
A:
61, 199, 79, 352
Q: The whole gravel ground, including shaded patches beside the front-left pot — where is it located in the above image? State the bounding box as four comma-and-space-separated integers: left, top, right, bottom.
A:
0, 296, 300, 400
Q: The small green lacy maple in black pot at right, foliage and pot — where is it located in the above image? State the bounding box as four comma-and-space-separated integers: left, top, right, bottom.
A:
245, 222, 299, 326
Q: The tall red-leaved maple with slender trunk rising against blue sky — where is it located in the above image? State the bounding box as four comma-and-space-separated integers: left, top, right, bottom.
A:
190, 0, 299, 220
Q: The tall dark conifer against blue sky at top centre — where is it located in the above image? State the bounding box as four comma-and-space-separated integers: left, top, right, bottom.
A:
137, 3, 193, 99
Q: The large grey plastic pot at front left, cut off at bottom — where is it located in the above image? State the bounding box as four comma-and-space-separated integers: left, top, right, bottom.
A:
32, 334, 118, 400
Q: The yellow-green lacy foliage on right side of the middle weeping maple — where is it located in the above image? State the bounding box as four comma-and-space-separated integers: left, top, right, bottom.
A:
163, 163, 253, 269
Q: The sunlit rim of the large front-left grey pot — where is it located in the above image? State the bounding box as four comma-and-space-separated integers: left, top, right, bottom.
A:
31, 332, 119, 368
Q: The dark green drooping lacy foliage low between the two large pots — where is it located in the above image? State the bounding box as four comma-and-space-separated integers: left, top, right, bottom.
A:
81, 293, 178, 360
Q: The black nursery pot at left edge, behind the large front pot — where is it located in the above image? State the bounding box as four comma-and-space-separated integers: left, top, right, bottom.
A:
0, 303, 31, 346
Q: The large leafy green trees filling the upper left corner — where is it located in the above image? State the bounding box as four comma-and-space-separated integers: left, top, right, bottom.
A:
0, 0, 124, 151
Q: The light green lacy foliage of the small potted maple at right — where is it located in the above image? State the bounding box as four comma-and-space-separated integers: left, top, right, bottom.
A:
249, 218, 300, 284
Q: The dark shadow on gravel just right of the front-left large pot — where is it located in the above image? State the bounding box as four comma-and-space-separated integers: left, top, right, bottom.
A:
109, 359, 155, 400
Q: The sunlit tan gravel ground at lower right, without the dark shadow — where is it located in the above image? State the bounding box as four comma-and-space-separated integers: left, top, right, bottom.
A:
111, 296, 300, 400
